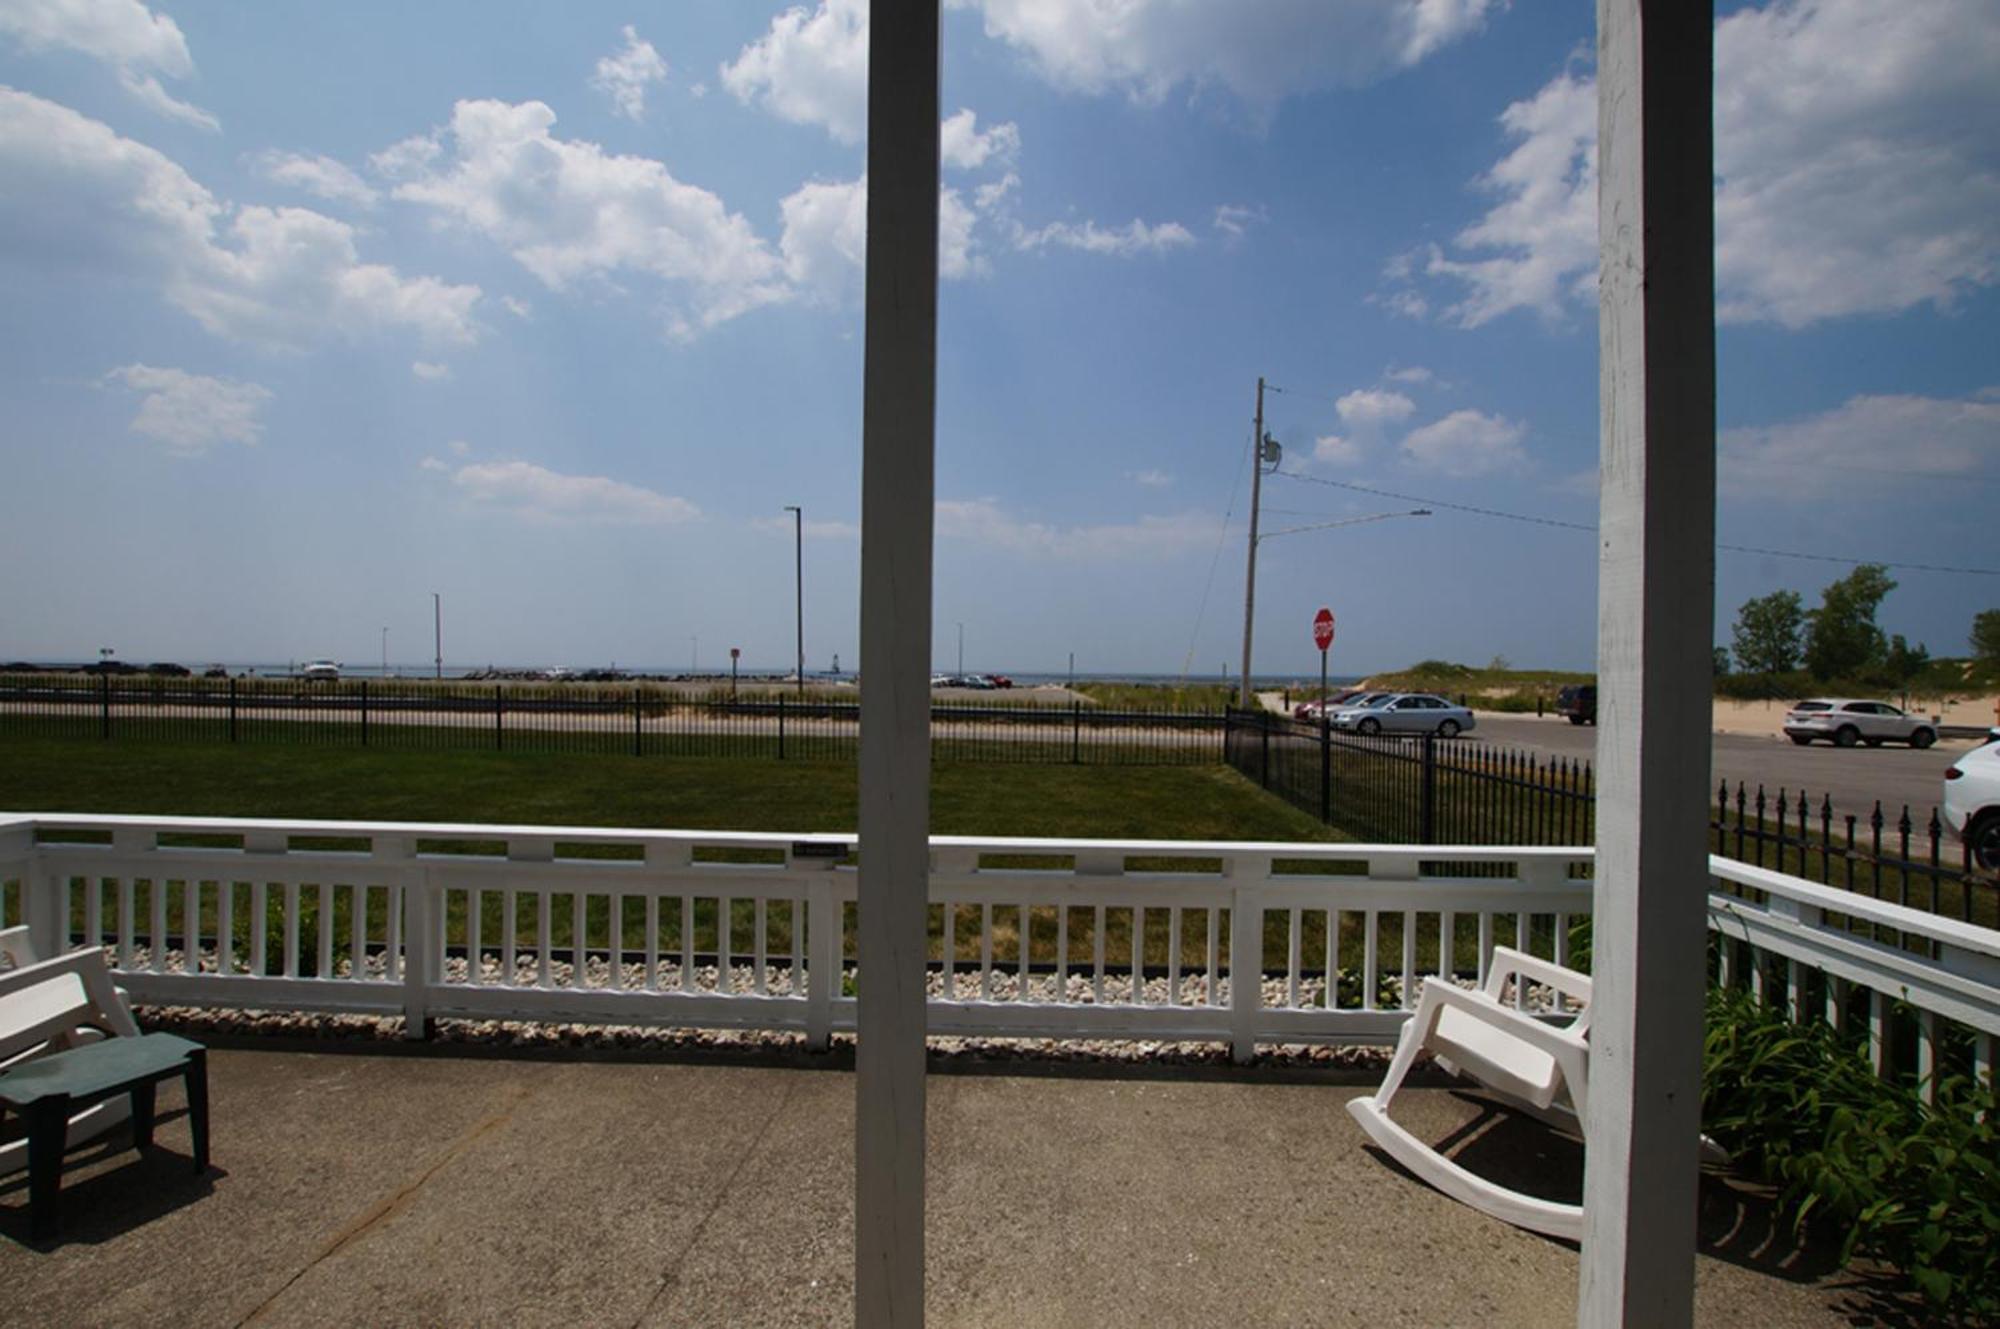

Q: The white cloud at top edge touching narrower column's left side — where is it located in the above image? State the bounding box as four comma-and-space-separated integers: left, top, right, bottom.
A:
722, 0, 868, 144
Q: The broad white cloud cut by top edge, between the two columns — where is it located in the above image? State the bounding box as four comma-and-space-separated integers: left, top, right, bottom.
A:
964, 0, 1494, 108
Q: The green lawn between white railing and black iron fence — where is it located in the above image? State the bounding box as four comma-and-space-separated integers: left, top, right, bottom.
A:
0, 741, 1342, 841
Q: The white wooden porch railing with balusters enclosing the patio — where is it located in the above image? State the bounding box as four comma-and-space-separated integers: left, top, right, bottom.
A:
0, 815, 2000, 1077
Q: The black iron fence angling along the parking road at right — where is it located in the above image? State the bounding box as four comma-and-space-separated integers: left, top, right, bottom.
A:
1222, 709, 2000, 927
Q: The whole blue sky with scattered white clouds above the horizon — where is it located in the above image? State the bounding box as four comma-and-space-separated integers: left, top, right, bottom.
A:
0, 0, 2000, 675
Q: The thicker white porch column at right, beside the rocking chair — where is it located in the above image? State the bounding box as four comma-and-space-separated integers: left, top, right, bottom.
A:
1578, 0, 1716, 1327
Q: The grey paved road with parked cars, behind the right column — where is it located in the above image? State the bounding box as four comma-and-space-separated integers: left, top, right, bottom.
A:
1476, 715, 1972, 823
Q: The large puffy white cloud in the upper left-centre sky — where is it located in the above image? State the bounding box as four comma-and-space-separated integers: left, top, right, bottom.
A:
392, 102, 790, 340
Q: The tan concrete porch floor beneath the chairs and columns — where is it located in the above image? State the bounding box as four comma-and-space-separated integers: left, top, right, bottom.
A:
0, 1047, 1880, 1329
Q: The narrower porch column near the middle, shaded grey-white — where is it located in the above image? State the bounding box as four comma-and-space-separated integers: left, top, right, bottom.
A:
854, 0, 938, 1329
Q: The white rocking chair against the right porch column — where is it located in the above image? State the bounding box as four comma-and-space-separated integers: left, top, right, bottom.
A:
1348, 947, 1590, 1241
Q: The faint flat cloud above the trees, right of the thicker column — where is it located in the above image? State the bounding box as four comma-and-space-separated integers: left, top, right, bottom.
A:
1718, 394, 2000, 502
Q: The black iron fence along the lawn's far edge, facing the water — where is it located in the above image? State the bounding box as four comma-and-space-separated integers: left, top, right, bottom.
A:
0, 675, 1222, 765
